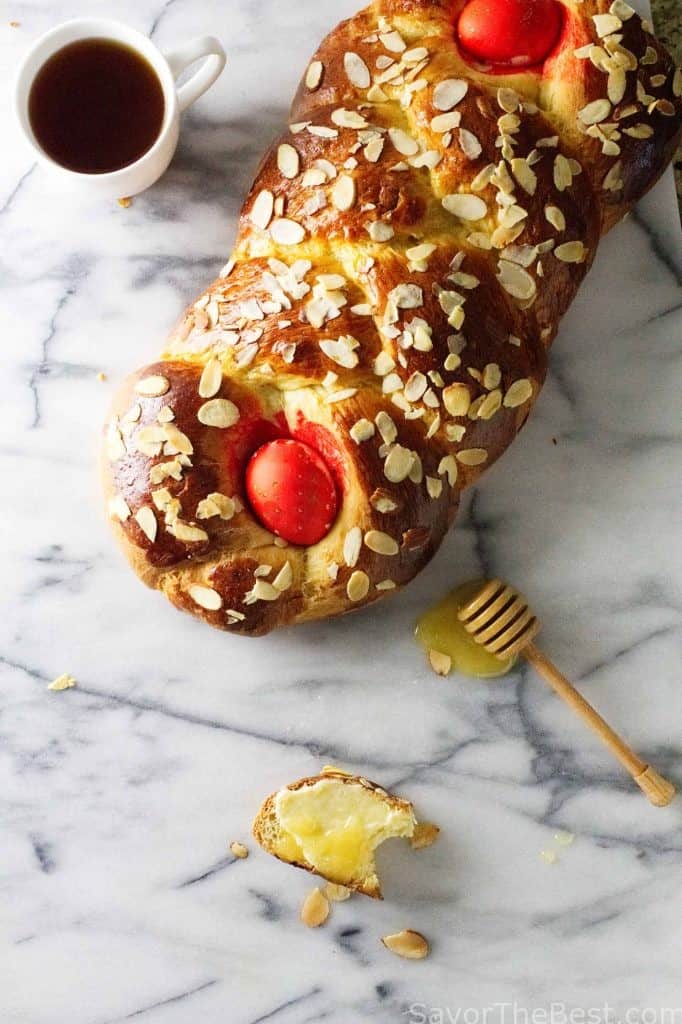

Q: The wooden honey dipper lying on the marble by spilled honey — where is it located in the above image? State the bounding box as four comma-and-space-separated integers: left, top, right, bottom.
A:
457, 580, 675, 807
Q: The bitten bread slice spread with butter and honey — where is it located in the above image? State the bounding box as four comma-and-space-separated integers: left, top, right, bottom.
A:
253, 769, 417, 899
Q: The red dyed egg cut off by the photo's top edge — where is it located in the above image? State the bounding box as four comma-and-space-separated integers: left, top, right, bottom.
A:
457, 0, 562, 68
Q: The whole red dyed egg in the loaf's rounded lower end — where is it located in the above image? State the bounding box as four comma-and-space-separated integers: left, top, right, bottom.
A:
246, 438, 338, 546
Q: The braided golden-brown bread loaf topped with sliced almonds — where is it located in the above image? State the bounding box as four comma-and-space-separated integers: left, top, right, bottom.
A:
103, 0, 682, 635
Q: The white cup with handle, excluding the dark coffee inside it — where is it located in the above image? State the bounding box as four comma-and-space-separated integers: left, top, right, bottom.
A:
14, 17, 225, 199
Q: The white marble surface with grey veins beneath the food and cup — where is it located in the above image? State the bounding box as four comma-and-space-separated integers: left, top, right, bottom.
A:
0, 0, 682, 1024
